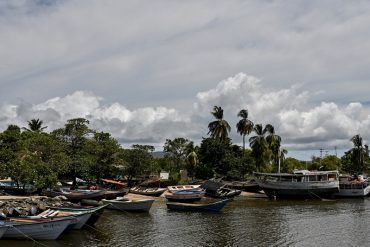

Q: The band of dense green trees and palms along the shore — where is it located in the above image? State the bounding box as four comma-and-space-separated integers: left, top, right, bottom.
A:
0, 106, 370, 189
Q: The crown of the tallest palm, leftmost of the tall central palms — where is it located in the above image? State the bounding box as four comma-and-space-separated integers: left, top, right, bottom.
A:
208, 106, 231, 140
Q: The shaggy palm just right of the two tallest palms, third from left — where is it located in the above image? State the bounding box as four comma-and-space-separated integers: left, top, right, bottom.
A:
249, 124, 269, 171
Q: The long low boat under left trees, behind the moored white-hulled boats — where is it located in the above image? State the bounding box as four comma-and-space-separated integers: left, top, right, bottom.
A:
43, 189, 106, 202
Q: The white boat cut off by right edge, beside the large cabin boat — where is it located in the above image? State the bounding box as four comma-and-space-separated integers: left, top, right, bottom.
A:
334, 176, 370, 197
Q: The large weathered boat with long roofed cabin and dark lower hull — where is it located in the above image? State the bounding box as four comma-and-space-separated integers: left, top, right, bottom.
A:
254, 170, 339, 198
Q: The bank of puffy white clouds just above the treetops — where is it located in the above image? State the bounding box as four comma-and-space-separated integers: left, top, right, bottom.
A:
0, 73, 370, 156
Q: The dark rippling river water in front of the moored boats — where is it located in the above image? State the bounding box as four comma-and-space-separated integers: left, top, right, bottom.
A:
0, 197, 370, 247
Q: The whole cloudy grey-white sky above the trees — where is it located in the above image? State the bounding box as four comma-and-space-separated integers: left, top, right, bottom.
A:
0, 0, 370, 159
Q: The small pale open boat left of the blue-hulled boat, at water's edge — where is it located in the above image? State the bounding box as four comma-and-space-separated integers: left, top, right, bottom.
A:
102, 197, 154, 212
